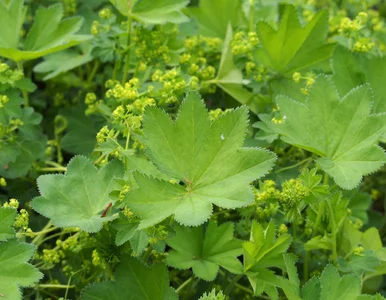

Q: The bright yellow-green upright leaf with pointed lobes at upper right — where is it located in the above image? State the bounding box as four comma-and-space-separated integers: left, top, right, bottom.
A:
256, 5, 334, 74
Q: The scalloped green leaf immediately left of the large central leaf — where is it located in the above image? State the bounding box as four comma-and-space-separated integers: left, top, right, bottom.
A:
32, 156, 123, 232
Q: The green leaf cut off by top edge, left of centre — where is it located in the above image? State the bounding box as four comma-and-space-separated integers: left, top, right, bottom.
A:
110, 0, 189, 24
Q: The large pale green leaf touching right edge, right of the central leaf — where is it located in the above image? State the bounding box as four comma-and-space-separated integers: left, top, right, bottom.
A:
269, 76, 386, 189
